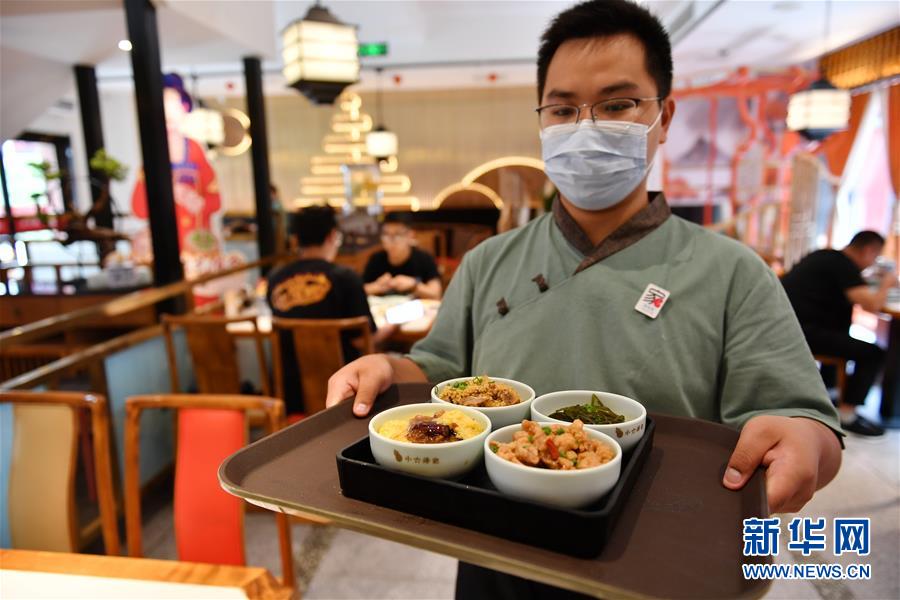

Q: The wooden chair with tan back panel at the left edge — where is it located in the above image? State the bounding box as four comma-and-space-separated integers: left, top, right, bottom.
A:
0, 392, 119, 555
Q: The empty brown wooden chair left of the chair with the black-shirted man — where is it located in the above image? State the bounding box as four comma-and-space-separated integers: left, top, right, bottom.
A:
162, 315, 272, 398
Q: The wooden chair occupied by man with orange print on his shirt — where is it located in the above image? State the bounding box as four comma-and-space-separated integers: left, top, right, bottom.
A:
272, 317, 375, 415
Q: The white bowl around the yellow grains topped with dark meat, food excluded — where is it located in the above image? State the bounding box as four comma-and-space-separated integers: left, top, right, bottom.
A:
369, 402, 491, 478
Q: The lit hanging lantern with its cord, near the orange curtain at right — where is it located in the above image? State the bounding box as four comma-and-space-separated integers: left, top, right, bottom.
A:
787, 0, 850, 140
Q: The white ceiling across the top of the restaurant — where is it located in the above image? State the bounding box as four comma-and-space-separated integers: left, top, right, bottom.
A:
0, 0, 900, 135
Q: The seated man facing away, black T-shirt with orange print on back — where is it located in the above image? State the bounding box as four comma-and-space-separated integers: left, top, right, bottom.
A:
267, 206, 395, 413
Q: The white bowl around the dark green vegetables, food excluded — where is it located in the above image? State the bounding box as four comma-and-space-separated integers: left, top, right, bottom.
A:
531, 390, 647, 452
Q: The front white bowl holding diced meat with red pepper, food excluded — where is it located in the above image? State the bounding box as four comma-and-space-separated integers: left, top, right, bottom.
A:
484, 423, 622, 508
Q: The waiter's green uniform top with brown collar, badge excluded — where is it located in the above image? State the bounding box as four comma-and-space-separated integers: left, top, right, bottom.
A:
408, 193, 840, 432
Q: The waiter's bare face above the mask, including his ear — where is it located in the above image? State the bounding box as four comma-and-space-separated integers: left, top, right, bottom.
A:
541, 34, 675, 160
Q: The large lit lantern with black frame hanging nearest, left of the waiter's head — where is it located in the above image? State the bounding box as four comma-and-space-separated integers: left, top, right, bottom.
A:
281, 1, 359, 104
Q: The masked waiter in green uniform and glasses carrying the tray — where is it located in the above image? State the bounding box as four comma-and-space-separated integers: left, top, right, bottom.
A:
327, 0, 842, 598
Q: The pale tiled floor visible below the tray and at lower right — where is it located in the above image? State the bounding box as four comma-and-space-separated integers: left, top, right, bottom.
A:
144, 408, 900, 600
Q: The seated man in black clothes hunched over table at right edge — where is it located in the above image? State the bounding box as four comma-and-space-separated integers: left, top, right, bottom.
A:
782, 231, 896, 436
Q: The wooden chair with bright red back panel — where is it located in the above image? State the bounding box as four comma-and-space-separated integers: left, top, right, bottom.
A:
125, 394, 294, 587
